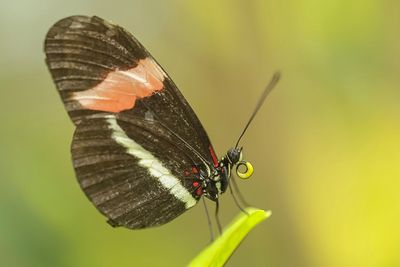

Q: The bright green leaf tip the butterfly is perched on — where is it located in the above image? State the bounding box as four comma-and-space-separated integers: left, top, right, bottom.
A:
188, 208, 271, 267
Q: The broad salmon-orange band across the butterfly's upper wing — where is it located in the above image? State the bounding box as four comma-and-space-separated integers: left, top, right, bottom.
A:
72, 58, 165, 112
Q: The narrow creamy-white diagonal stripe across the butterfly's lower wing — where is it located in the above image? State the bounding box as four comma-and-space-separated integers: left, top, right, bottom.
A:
107, 115, 196, 209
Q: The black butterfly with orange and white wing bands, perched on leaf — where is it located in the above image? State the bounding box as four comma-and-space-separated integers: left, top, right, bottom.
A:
44, 16, 279, 229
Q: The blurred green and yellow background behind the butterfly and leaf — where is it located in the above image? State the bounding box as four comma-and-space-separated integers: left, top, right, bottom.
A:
0, 0, 400, 267
